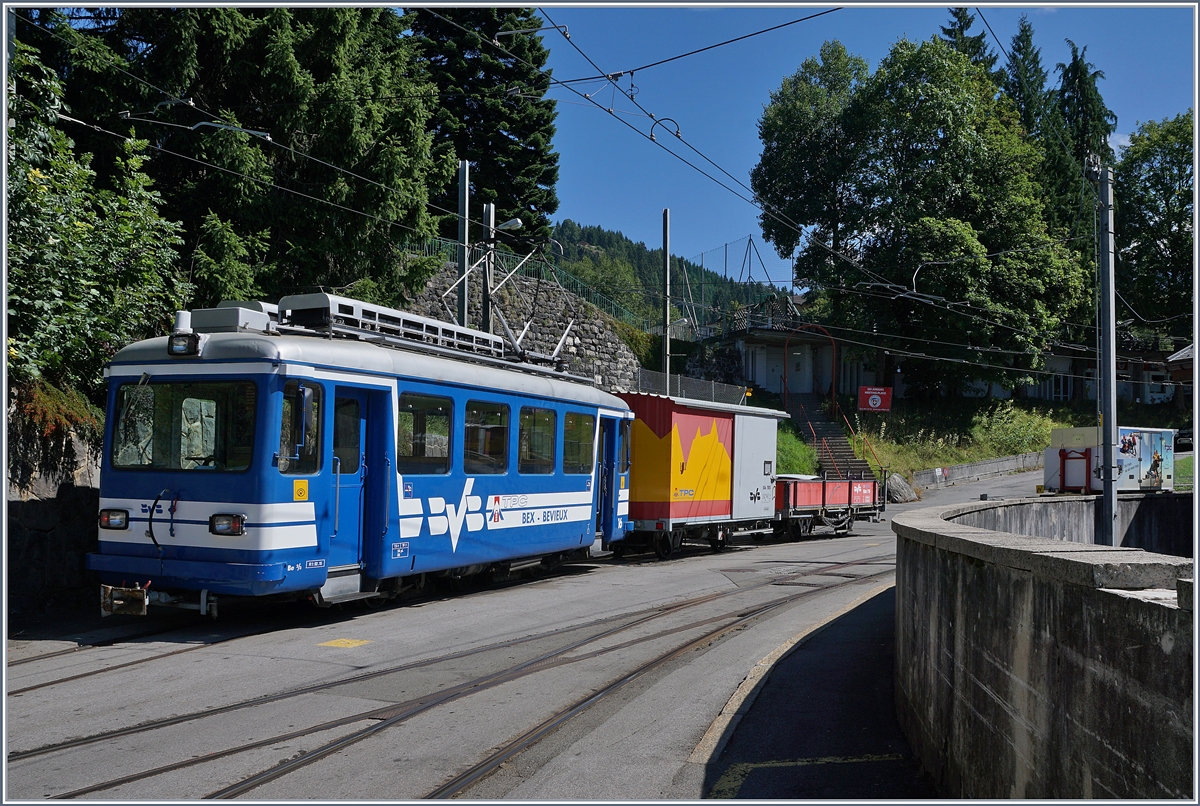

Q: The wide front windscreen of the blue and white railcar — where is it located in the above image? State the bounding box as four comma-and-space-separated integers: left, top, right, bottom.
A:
110, 380, 258, 473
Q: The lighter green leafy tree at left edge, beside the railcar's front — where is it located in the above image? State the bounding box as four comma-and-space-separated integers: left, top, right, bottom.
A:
6, 41, 190, 477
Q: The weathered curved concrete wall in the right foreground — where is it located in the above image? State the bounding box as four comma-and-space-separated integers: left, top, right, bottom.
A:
892, 499, 1193, 799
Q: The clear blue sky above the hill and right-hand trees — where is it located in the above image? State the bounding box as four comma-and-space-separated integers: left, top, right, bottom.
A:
542, 5, 1196, 283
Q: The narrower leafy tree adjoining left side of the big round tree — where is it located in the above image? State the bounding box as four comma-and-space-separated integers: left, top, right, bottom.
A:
750, 41, 868, 284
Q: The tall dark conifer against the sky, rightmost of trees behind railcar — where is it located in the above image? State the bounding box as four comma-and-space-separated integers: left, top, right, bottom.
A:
412, 8, 558, 237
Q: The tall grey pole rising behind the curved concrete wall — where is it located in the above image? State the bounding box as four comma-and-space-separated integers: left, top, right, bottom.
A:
1087, 155, 1117, 546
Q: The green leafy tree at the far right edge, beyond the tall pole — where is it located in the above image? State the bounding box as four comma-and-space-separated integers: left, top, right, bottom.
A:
1114, 109, 1195, 336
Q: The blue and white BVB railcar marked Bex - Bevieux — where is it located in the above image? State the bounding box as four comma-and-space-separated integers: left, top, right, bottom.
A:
88, 294, 634, 614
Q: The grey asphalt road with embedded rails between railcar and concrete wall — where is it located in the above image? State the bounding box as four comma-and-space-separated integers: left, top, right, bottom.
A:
6, 465, 1040, 801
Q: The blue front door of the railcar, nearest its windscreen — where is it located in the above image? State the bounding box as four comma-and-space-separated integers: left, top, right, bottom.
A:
329, 386, 368, 569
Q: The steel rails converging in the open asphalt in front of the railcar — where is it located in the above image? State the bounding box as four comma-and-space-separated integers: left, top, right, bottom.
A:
8, 554, 893, 799
